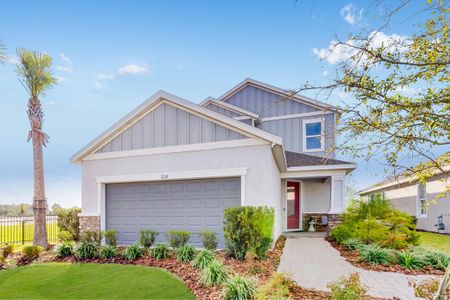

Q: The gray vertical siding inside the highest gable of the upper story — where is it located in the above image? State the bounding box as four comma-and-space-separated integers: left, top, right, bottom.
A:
224, 86, 319, 118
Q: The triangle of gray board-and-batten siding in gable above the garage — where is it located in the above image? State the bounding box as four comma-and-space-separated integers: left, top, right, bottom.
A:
97, 104, 246, 153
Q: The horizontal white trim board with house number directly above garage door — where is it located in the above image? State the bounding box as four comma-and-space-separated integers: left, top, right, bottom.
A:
95, 168, 247, 183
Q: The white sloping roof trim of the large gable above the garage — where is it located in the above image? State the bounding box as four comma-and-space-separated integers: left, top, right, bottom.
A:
71, 91, 282, 163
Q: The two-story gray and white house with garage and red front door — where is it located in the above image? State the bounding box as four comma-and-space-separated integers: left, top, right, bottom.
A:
71, 79, 356, 245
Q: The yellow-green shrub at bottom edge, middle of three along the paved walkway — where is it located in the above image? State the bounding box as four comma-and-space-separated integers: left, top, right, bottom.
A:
328, 273, 367, 300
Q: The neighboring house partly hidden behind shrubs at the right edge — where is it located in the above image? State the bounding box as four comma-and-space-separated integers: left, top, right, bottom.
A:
359, 165, 450, 233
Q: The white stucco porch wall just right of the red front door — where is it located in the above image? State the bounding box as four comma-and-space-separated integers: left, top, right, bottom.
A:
301, 179, 331, 213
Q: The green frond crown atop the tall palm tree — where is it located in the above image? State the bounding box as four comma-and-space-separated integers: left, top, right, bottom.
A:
17, 48, 56, 98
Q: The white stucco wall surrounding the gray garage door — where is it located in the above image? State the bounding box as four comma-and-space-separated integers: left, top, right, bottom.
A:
81, 144, 283, 238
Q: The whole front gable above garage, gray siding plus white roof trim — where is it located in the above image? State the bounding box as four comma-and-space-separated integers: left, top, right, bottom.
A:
71, 91, 281, 163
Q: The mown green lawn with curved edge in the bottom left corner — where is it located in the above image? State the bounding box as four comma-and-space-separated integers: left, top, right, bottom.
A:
0, 263, 195, 299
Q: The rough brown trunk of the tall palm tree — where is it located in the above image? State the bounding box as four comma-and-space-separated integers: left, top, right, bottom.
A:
28, 98, 48, 247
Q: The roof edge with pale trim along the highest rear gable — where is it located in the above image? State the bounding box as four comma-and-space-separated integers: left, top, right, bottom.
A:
217, 78, 342, 114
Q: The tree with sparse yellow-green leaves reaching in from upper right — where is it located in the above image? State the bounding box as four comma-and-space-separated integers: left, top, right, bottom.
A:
296, 0, 450, 192
